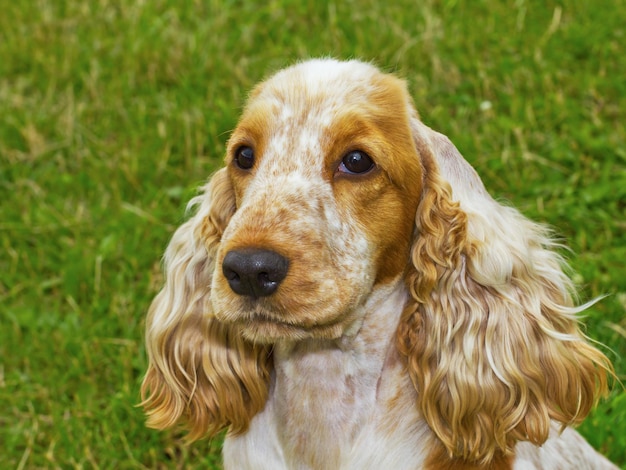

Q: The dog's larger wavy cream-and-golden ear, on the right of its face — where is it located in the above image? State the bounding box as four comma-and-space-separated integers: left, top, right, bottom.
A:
398, 112, 612, 464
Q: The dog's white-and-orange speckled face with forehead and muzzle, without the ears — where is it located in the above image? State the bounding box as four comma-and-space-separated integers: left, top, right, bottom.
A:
211, 61, 422, 342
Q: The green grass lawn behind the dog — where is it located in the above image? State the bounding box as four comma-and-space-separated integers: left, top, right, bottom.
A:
0, 0, 626, 469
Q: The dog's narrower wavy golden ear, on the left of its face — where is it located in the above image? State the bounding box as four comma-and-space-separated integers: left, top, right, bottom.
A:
142, 169, 270, 440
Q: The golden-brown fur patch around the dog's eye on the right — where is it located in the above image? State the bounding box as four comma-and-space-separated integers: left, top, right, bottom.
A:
327, 73, 422, 283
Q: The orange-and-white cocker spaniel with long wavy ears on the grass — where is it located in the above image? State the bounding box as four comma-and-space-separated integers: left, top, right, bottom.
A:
142, 59, 615, 470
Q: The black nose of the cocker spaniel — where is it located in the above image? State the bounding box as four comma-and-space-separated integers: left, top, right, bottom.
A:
222, 248, 289, 299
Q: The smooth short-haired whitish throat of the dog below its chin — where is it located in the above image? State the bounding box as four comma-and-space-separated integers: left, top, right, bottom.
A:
270, 279, 407, 468
